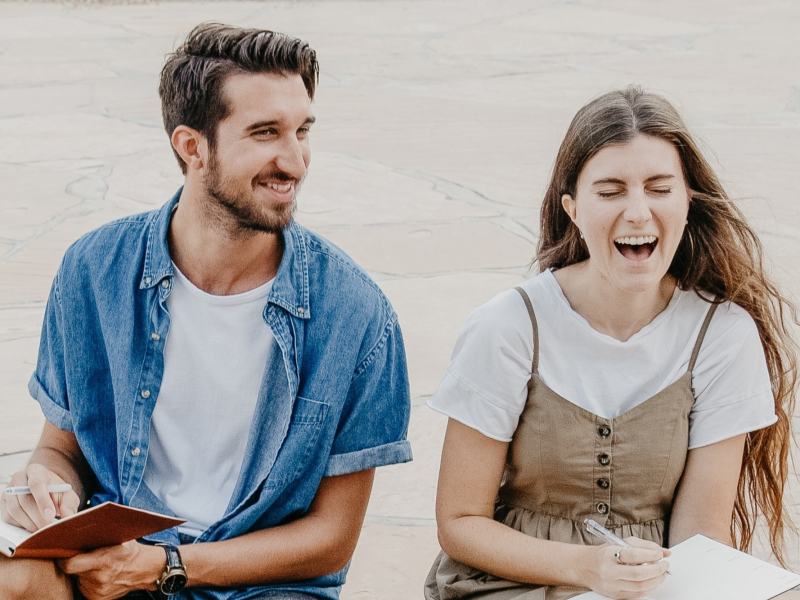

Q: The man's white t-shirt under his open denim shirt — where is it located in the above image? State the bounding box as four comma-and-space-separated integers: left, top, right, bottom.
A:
144, 268, 274, 535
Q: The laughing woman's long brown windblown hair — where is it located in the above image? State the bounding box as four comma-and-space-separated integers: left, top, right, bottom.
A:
536, 87, 797, 565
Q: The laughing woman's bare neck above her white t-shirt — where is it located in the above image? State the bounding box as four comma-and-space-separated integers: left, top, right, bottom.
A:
555, 261, 676, 342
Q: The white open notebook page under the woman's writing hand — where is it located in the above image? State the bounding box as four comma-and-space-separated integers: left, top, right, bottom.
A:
573, 535, 800, 600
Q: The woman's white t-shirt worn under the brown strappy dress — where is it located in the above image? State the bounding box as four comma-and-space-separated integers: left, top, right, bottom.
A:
428, 271, 777, 448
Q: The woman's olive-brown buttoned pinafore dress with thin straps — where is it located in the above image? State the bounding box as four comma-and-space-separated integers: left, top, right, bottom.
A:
425, 288, 717, 600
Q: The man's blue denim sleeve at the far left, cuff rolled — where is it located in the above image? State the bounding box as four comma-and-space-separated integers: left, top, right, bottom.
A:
28, 275, 72, 431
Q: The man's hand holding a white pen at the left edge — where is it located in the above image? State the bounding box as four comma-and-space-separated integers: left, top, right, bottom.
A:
0, 463, 80, 531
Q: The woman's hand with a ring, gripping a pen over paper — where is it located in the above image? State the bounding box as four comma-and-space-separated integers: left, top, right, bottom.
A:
588, 537, 670, 600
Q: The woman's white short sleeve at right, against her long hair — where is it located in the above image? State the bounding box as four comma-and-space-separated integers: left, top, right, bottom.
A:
689, 304, 777, 449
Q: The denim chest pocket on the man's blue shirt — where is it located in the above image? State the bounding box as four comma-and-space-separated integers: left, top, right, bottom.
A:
270, 396, 330, 485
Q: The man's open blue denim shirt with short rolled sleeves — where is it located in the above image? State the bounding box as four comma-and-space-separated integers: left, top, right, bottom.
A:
28, 191, 411, 599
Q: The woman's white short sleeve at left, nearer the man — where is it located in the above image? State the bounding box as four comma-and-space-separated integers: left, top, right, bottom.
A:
428, 290, 533, 442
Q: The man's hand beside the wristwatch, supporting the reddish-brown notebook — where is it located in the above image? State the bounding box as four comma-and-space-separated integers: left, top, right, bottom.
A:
59, 541, 166, 600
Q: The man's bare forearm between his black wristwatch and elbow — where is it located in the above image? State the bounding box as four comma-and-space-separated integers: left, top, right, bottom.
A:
180, 514, 358, 587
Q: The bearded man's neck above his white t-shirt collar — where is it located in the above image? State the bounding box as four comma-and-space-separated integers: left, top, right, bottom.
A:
169, 180, 283, 295
